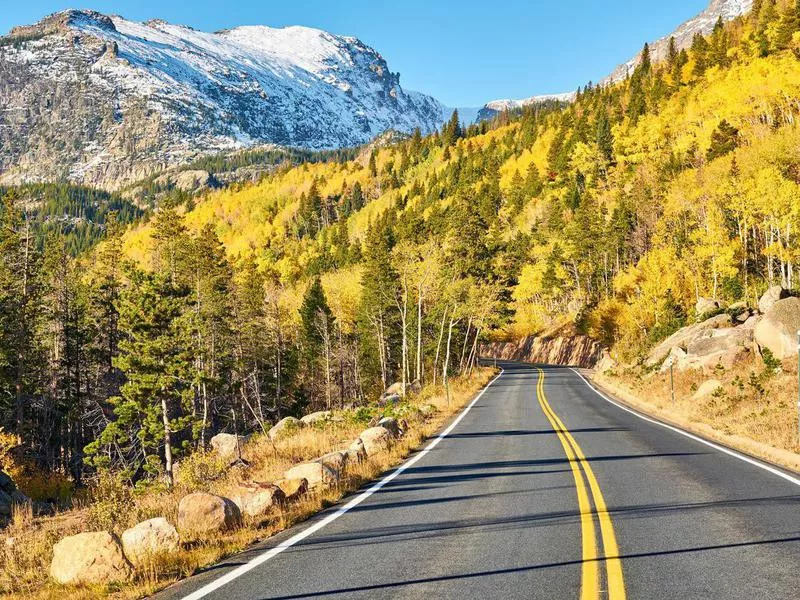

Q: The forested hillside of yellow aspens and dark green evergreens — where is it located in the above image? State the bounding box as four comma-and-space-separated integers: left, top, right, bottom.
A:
0, 0, 800, 490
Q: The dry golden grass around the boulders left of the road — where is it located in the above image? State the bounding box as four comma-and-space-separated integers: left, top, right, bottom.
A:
0, 369, 494, 600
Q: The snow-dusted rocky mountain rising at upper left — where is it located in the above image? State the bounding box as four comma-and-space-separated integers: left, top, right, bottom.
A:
0, 10, 450, 186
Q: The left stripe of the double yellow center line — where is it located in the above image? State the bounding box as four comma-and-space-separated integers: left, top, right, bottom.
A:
536, 375, 600, 600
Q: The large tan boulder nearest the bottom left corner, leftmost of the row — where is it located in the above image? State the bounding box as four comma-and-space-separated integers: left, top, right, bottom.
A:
50, 531, 133, 585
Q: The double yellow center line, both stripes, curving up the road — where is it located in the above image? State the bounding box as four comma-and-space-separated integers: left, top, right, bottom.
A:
536, 369, 625, 600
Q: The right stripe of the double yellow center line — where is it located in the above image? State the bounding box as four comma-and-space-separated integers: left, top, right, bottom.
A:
537, 369, 626, 600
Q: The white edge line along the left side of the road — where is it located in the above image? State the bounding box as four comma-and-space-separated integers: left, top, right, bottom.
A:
183, 369, 505, 600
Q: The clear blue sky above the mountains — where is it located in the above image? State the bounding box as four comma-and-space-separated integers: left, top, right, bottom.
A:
0, 0, 708, 106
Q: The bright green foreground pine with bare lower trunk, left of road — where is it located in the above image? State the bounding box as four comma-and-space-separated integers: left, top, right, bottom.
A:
86, 269, 194, 485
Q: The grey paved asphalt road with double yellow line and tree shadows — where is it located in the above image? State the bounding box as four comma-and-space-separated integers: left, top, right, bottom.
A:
156, 363, 800, 600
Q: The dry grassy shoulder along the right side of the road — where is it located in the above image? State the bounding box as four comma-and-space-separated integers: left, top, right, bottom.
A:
589, 357, 800, 472
